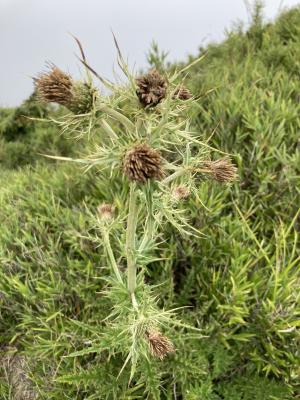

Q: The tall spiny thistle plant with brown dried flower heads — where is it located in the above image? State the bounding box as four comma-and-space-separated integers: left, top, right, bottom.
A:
35, 36, 236, 374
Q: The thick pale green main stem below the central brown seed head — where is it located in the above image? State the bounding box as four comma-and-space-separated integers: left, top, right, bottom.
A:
126, 183, 137, 300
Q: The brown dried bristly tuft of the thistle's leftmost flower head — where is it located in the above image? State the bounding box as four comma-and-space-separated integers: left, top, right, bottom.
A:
34, 66, 73, 106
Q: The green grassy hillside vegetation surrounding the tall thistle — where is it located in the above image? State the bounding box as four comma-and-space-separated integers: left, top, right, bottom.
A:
0, 3, 300, 400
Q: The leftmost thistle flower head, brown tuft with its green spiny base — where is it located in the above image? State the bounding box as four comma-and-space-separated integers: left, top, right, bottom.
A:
34, 66, 97, 114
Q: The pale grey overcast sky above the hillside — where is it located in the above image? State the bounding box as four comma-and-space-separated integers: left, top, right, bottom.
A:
0, 0, 300, 106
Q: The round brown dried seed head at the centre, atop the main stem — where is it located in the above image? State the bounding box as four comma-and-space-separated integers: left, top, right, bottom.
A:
123, 143, 163, 183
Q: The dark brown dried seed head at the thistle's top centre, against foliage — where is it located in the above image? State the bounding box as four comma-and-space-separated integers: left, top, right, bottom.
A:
136, 69, 168, 107
